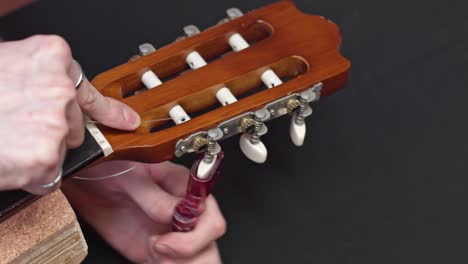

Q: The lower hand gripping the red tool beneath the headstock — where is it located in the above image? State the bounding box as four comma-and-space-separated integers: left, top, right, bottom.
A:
62, 161, 226, 264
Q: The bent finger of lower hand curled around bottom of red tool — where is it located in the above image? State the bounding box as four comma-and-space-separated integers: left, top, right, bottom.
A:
154, 196, 226, 258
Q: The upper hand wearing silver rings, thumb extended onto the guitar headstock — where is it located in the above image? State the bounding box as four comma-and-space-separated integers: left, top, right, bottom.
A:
0, 35, 140, 194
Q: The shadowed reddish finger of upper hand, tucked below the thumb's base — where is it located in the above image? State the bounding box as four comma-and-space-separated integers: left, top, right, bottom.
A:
65, 101, 84, 148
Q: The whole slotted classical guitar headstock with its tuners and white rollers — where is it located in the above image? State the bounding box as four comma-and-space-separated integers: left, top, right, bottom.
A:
92, 1, 350, 165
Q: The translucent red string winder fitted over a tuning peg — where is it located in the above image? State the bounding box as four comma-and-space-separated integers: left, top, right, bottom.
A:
172, 151, 224, 232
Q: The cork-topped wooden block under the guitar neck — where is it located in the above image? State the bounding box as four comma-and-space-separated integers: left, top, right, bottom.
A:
0, 190, 88, 264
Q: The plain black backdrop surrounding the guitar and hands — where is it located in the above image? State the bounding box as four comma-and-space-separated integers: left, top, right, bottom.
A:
0, 0, 468, 263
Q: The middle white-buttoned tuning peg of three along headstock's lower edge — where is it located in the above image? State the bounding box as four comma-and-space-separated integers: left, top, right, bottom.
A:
239, 109, 270, 163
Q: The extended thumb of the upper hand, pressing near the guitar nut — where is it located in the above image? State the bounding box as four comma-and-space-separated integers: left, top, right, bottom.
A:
78, 78, 141, 130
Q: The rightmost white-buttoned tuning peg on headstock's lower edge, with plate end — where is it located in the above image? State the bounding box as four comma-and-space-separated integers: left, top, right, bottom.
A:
287, 83, 322, 147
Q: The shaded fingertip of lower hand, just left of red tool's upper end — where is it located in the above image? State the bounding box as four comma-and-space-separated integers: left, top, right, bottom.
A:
147, 161, 190, 197
